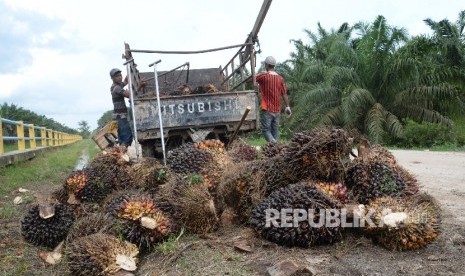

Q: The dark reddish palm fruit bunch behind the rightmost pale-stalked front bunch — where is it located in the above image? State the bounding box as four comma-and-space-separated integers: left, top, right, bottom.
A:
344, 158, 406, 204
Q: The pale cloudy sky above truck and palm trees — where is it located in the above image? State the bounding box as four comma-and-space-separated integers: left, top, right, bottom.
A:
0, 0, 465, 129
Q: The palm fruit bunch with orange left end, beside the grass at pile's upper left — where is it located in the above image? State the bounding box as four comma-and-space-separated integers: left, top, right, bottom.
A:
64, 168, 112, 202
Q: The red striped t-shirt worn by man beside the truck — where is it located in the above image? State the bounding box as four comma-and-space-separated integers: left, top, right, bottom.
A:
256, 71, 287, 113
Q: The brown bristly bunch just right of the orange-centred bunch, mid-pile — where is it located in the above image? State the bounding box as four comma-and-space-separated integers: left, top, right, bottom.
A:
155, 175, 219, 234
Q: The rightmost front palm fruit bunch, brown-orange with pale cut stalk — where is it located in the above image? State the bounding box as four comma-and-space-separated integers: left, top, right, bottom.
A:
364, 194, 441, 251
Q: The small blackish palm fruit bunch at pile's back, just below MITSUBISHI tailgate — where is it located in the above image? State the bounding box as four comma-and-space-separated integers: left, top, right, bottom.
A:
168, 143, 212, 174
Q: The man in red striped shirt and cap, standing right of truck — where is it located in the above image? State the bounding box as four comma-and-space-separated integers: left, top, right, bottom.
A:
256, 56, 292, 142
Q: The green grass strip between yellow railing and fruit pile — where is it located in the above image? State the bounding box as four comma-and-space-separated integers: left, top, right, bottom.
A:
0, 139, 100, 196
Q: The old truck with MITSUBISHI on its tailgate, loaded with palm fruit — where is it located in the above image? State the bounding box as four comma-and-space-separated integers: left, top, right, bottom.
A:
125, 44, 259, 157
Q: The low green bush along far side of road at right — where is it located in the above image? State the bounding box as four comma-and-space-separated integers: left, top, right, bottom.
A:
394, 120, 457, 148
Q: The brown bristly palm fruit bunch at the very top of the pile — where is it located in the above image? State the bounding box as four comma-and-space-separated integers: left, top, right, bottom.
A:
283, 127, 352, 181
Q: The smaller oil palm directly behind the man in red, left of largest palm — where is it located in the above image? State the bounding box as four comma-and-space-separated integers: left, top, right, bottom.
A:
277, 23, 355, 130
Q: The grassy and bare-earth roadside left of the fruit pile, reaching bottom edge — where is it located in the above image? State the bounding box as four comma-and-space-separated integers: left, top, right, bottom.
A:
0, 139, 100, 275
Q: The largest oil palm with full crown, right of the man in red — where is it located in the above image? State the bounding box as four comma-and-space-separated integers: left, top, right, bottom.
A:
289, 16, 458, 143
